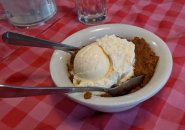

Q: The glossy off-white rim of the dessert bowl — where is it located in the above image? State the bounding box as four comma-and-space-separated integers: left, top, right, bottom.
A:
50, 24, 173, 107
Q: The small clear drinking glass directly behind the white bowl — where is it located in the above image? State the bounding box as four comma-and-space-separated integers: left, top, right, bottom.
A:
75, 0, 106, 24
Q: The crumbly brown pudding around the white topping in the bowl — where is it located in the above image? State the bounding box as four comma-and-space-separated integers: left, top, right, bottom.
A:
67, 37, 159, 99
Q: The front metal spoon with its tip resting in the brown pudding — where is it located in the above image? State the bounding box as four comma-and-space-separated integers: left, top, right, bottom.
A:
0, 75, 144, 98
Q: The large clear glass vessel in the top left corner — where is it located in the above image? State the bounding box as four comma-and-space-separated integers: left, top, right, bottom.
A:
0, 0, 57, 26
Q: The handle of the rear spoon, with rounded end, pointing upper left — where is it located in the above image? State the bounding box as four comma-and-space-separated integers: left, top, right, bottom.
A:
2, 32, 79, 51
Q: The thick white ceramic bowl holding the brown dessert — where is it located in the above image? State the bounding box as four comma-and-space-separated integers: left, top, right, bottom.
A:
50, 24, 172, 112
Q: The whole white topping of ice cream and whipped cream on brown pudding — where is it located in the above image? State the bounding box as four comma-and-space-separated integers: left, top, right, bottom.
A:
73, 35, 135, 88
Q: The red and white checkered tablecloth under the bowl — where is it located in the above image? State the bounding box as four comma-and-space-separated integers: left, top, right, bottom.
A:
0, 0, 185, 130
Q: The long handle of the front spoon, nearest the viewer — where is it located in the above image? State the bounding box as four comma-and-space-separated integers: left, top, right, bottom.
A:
0, 84, 107, 98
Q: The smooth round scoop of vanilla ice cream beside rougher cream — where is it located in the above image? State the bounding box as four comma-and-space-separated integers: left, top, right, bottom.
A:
74, 43, 110, 81
